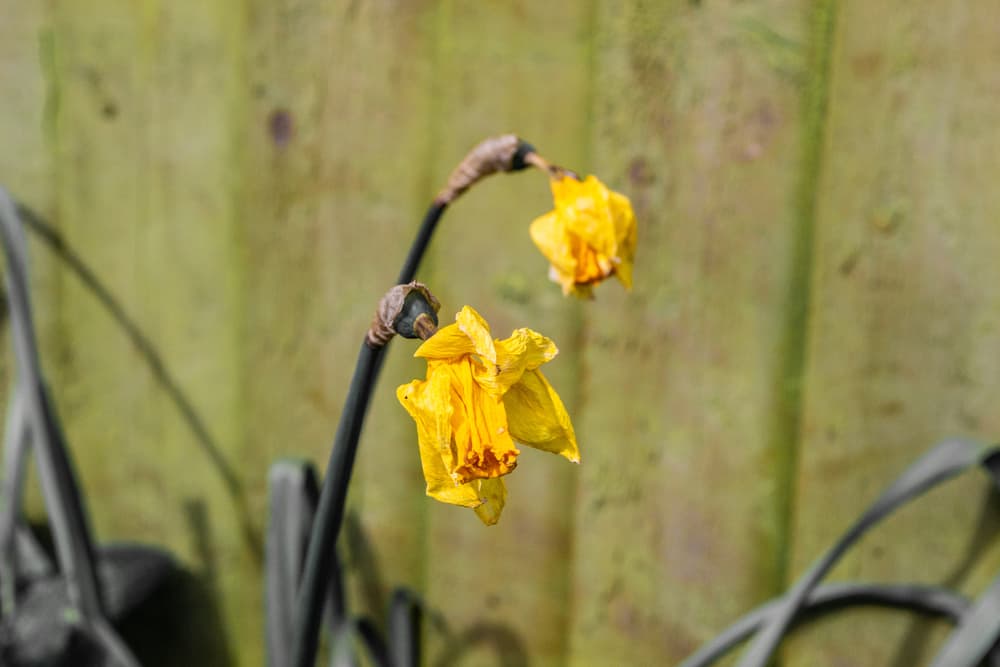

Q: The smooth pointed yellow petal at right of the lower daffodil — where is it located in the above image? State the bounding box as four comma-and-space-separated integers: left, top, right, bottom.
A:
503, 370, 580, 463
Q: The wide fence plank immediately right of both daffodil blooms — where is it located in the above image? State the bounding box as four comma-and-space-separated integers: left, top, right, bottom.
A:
570, 1, 808, 665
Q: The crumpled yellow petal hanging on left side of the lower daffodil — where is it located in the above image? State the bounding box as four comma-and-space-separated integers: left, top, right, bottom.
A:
396, 373, 481, 507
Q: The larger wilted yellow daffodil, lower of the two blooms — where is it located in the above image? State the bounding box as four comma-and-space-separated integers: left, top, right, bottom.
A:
396, 306, 580, 525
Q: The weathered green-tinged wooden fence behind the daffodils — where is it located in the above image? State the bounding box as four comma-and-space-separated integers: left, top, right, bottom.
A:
0, 0, 1000, 667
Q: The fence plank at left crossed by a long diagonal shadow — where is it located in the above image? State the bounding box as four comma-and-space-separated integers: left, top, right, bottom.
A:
48, 0, 248, 665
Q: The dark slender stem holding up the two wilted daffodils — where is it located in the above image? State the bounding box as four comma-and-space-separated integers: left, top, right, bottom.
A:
292, 201, 448, 667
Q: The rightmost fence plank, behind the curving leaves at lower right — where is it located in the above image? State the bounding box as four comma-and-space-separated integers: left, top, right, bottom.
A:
788, 2, 1000, 665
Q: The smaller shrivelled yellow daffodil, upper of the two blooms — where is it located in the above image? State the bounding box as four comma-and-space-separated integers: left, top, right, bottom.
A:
531, 176, 636, 296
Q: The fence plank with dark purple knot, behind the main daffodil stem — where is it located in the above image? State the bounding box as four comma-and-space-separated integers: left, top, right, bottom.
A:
244, 0, 434, 632
